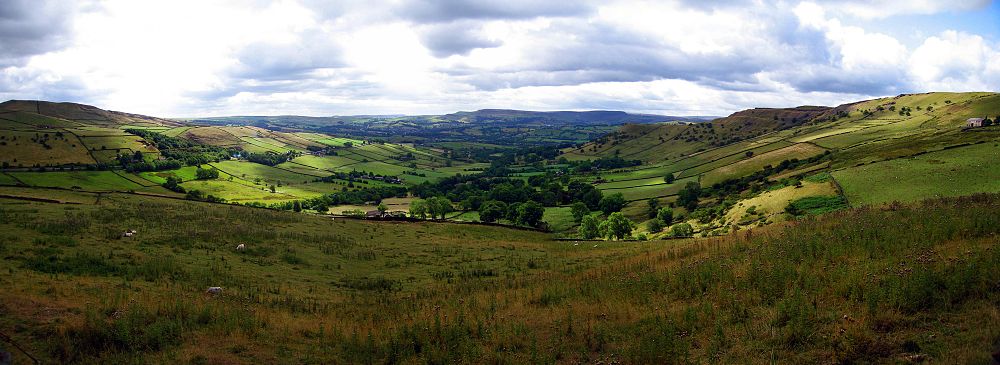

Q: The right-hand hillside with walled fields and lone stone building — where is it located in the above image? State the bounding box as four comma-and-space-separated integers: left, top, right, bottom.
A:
562, 93, 1000, 233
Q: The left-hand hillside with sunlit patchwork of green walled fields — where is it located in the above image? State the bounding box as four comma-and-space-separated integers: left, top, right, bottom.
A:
0, 100, 485, 210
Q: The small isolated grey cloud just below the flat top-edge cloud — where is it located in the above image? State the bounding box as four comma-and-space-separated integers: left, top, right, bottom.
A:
420, 21, 503, 58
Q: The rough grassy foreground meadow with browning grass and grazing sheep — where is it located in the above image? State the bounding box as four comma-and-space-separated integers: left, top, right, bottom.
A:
0, 192, 1000, 363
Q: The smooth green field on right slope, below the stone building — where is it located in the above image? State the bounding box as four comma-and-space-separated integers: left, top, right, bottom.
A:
833, 143, 1000, 205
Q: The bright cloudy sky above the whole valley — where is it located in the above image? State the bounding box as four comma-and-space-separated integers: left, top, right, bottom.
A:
0, 0, 1000, 117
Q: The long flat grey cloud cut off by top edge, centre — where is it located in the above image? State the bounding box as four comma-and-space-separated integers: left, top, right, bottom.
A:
397, 0, 592, 23
